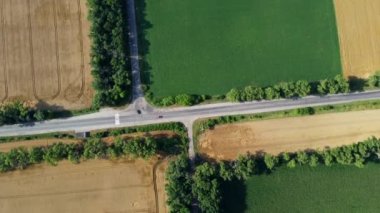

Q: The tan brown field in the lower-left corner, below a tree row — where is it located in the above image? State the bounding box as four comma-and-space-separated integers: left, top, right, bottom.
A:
0, 160, 167, 213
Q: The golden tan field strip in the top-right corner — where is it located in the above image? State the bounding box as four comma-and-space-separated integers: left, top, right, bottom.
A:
334, 0, 380, 78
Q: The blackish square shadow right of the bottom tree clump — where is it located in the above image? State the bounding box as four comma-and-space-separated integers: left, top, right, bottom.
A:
220, 180, 247, 213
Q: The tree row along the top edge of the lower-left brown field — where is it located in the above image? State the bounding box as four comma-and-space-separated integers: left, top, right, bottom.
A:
0, 138, 163, 172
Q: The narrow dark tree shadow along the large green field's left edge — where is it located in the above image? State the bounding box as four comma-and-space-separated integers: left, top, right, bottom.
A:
135, 0, 153, 89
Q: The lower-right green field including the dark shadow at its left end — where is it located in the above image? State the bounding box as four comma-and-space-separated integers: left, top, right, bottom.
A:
223, 163, 380, 213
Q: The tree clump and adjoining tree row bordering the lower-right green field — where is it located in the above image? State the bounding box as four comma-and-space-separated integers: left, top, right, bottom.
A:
166, 137, 380, 213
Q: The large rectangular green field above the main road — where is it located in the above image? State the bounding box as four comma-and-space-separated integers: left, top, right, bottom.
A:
142, 0, 341, 97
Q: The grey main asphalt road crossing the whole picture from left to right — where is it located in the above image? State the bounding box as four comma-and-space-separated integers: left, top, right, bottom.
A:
0, 91, 380, 136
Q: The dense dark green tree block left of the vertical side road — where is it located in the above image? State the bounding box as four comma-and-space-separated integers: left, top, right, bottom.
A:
87, 0, 131, 107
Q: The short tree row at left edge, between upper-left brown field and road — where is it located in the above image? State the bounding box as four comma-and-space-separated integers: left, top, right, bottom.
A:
0, 101, 51, 126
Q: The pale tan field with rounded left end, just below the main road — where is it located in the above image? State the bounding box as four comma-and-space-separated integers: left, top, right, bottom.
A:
197, 110, 380, 160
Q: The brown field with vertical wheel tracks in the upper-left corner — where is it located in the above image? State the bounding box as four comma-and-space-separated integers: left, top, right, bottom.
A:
0, 0, 93, 109
